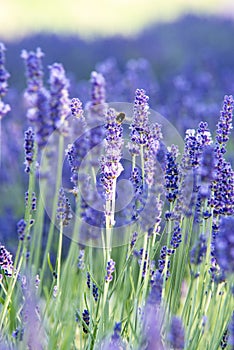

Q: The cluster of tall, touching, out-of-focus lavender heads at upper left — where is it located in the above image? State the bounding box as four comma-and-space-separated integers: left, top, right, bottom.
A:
21, 48, 70, 148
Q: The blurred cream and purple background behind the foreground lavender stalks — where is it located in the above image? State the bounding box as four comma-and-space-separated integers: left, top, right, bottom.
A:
0, 0, 234, 249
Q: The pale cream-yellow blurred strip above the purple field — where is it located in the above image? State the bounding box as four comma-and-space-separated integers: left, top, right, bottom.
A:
0, 0, 234, 39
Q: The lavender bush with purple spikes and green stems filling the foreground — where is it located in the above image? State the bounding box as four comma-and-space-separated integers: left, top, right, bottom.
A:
0, 36, 234, 350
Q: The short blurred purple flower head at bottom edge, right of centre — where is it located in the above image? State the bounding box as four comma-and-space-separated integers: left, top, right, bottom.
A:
168, 316, 184, 349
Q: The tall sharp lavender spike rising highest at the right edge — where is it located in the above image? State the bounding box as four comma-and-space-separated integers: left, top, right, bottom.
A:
216, 95, 234, 153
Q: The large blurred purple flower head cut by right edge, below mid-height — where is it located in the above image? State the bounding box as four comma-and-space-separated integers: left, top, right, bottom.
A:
214, 217, 234, 274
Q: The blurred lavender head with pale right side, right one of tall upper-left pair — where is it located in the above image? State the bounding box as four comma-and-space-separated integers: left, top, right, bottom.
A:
49, 63, 70, 132
